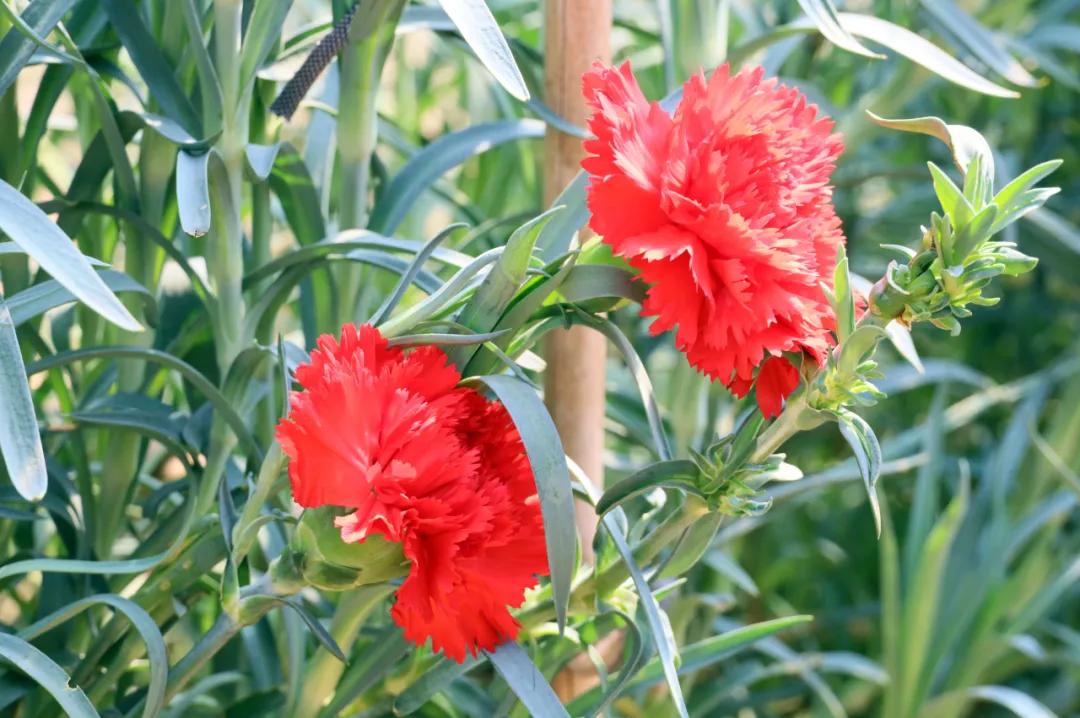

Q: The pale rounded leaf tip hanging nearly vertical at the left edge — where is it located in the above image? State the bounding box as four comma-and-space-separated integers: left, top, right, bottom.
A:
0, 295, 49, 501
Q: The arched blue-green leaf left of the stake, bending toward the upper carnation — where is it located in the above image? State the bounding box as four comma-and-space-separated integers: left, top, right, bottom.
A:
368, 120, 545, 234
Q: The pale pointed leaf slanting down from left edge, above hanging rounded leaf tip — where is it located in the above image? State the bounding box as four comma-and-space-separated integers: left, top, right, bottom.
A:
0, 180, 143, 331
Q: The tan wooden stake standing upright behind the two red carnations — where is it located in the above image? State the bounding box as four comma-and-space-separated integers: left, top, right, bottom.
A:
544, 0, 611, 563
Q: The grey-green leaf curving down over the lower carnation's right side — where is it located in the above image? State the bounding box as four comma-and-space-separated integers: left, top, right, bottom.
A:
467, 376, 578, 629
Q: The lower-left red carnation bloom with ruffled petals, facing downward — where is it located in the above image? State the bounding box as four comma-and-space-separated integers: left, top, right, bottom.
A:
278, 325, 548, 661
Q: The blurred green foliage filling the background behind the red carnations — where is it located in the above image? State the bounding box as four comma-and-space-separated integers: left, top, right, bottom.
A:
0, 0, 1080, 718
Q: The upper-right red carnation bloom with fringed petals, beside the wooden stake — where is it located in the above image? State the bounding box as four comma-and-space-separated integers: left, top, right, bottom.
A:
582, 64, 843, 417
